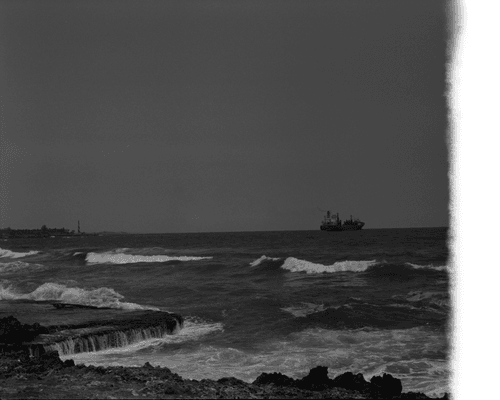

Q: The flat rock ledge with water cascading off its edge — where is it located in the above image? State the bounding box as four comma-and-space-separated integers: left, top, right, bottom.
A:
0, 300, 184, 356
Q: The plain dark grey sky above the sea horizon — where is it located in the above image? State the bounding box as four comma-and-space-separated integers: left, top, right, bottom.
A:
0, 0, 450, 232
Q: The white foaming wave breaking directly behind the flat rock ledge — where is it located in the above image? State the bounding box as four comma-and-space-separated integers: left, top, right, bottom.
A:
0, 282, 158, 310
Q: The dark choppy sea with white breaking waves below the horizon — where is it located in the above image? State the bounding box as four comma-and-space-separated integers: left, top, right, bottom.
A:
0, 228, 453, 396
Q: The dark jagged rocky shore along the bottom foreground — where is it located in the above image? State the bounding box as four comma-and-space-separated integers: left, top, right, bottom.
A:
0, 316, 448, 399
